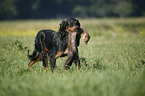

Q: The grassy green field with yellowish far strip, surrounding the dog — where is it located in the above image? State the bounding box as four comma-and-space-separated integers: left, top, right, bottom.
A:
0, 18, 145, 96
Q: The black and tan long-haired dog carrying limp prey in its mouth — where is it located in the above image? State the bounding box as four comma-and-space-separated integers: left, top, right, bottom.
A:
28, 18, 90, 70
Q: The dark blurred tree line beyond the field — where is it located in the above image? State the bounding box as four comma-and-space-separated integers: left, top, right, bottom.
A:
0, 0, 145, 20
